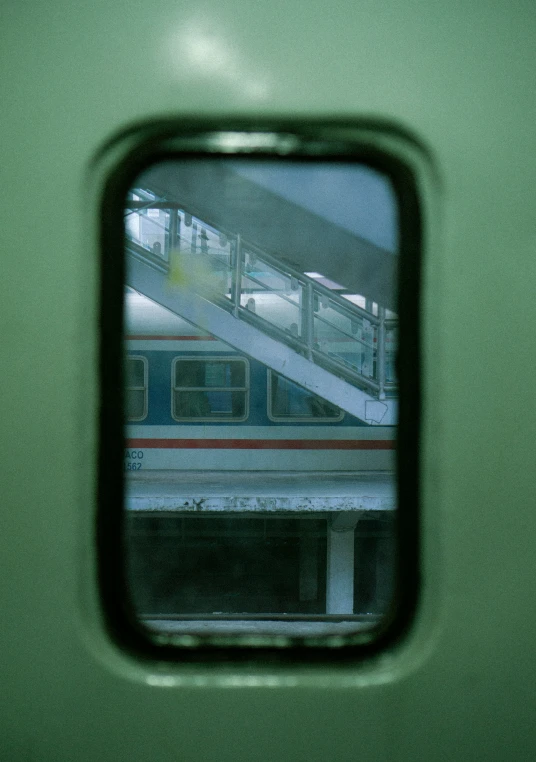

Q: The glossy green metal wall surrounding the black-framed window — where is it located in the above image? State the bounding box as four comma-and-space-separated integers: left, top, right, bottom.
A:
0, 0, 536, 762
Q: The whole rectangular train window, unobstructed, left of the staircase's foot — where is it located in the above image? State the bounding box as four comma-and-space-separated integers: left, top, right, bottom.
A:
173, 357, 249, 421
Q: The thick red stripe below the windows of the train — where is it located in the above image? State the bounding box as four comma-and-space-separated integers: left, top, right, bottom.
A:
126, 439, 396, 450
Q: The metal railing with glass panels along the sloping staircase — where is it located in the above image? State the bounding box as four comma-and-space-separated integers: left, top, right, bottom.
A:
125, 189, 397, 399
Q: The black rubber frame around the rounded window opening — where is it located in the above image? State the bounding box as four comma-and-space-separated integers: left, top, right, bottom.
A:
95, 121, 422, 668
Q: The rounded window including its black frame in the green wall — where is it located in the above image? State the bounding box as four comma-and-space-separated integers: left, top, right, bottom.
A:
97, 120, 421, 663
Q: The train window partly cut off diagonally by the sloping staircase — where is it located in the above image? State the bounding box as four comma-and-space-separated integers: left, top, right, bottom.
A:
268, 370, 344, 423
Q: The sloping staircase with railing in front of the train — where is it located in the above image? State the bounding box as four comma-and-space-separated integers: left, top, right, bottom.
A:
125, 188, 397, 425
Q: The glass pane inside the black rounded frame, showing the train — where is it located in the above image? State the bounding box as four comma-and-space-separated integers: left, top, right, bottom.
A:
115, 138, 416, 646
